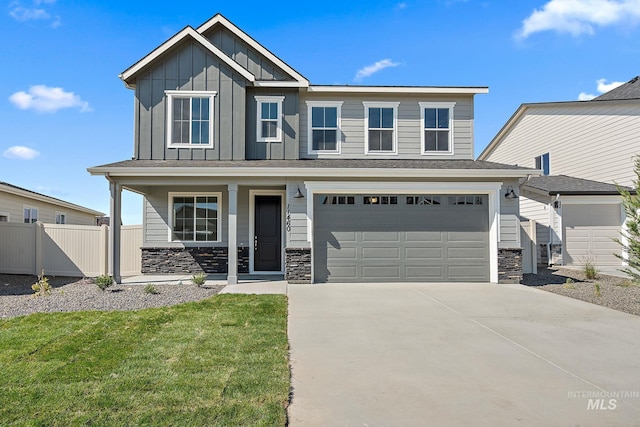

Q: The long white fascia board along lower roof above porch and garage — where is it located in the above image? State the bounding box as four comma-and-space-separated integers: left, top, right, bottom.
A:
87, 167, 531, 179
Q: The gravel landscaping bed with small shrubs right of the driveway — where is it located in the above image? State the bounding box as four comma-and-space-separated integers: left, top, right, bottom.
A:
522, 268, 640, 316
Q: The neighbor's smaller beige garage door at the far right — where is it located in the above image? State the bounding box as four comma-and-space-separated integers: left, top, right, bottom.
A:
562, 204, 622, 265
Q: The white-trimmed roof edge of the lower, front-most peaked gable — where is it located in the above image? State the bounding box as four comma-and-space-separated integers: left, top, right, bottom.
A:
118, 26, 256, 88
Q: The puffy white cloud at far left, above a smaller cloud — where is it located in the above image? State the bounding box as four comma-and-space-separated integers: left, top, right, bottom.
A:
9, 85, 92, 113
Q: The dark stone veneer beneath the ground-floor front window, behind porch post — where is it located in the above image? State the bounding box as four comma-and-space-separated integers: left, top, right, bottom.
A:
142, 247, 249, 274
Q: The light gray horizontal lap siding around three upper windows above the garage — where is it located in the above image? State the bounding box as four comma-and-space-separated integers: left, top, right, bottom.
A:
299, 92, 474, 160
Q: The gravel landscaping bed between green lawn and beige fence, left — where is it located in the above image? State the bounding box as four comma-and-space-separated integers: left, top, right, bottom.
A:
0, 274, 224, 318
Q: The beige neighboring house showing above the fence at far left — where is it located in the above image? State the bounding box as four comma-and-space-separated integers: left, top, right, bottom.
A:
0, 181, 104, 225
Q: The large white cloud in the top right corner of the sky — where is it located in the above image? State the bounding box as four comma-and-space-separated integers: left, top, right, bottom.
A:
516, 0, 640, 39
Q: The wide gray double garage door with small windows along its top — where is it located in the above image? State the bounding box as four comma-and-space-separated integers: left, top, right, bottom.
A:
313, 194, 490, 282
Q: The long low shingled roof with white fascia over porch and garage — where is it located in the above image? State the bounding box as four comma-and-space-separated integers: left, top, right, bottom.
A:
88, 159, 539, 178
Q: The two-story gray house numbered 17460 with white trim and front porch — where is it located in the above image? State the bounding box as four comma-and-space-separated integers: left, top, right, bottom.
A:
89, 15, 536, 283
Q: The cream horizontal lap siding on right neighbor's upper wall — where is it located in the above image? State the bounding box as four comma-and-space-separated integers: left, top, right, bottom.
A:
487, 101, 640, 185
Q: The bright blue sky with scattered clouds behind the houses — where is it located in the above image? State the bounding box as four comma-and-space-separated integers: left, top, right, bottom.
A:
0, 0, 640, 224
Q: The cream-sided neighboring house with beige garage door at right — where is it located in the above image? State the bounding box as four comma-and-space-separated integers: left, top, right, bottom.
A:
478, 77, 640, 266
